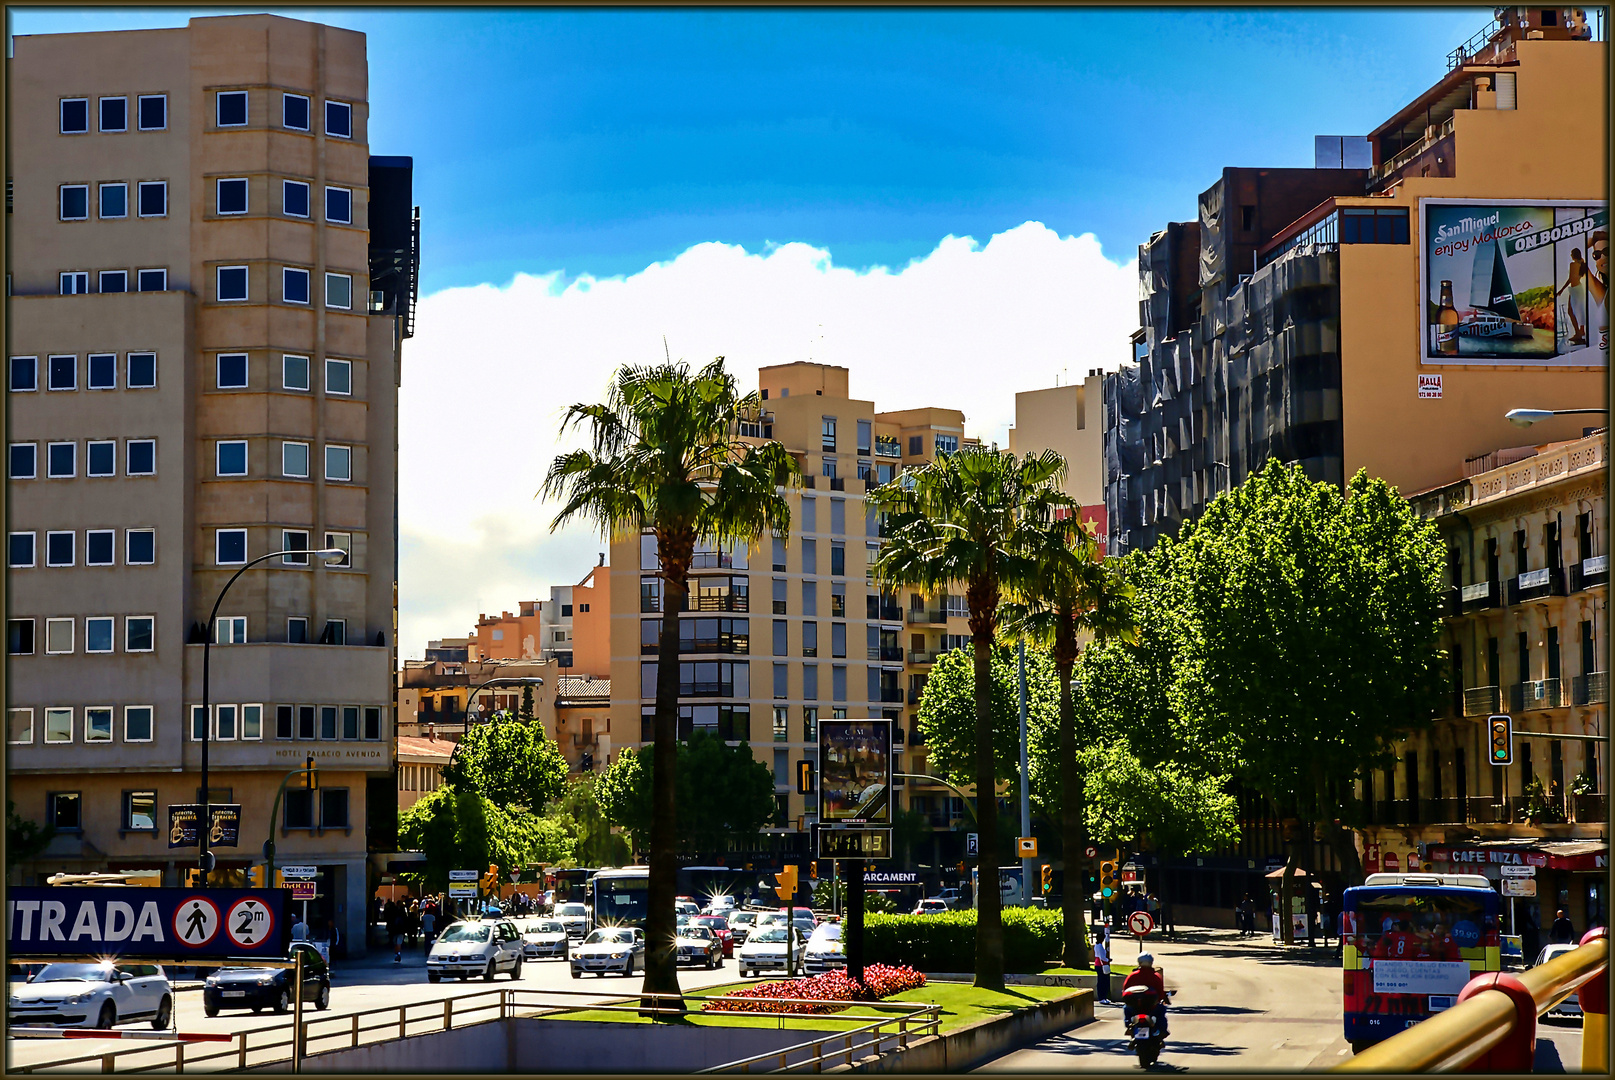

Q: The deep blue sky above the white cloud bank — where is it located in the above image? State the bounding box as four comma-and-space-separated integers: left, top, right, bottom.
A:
10, 8, 1489, 292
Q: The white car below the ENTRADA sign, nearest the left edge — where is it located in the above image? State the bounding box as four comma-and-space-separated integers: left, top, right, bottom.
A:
6, 962, 174, 1030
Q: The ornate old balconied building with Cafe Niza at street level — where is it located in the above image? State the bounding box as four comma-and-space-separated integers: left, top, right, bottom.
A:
1358, 431, 1609, 927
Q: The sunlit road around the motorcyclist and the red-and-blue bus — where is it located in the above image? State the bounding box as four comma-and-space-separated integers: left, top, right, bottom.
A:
977, 931, 1581, 1072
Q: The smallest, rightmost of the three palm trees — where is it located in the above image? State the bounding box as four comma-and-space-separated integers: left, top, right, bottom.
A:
1003, 517, 1139, 969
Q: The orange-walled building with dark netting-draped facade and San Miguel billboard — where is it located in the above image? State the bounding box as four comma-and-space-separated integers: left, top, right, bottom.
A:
1103, 8, 1609, 552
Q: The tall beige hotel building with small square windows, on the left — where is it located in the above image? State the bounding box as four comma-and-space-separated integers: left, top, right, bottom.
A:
6, 15, 418, 952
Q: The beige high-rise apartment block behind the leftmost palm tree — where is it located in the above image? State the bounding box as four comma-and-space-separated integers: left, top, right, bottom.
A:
596, 363, 969, 867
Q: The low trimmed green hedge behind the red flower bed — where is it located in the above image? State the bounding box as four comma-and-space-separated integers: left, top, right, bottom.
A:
864, 907, 1064, 973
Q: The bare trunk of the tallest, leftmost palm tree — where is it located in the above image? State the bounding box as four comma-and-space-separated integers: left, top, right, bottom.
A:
641, 571, 690, 1015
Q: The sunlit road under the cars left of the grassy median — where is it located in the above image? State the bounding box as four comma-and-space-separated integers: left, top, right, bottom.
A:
6, 948, 740, 1072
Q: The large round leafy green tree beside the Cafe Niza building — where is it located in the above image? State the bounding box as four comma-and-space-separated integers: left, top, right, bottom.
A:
1168, 462, 1445, 940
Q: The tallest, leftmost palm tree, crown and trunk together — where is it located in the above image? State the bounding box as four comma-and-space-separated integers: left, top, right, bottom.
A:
543, 357, 801, 1004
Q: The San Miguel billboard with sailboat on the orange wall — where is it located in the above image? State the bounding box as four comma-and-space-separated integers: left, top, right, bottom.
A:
1420, 199, 1610, 366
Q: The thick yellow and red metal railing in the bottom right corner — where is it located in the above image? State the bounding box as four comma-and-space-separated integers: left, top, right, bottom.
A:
1332, 931, 1610, 1074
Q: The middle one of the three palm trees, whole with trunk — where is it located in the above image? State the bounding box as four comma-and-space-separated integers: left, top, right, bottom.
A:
867, 447, 1071, 990
